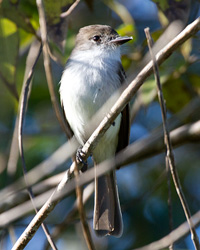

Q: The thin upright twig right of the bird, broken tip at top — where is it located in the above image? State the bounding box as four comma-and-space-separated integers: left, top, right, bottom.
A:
145, 28, 200, 250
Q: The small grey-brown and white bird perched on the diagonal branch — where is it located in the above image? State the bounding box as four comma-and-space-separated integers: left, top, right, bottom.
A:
60, 25, 132, 237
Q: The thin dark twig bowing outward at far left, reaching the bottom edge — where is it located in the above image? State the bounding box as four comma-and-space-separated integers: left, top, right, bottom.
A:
18, 43, 57, 250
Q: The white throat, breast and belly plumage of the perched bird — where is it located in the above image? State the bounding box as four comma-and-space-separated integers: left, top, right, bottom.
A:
60, 47, 121, 158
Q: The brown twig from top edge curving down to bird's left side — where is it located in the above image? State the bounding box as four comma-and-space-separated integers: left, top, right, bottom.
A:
36, 0, 71, 138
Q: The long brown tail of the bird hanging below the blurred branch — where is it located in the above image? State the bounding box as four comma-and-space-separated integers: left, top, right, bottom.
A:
93, 171, 123, 237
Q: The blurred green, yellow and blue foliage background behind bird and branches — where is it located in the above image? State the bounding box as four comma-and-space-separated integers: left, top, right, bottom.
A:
0, 0, 200, 250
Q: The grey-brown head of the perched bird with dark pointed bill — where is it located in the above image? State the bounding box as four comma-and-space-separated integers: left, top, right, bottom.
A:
76, 25, 132, 50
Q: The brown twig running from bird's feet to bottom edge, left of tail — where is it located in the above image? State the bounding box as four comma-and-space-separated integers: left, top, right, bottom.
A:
74, 157, 95, 250
